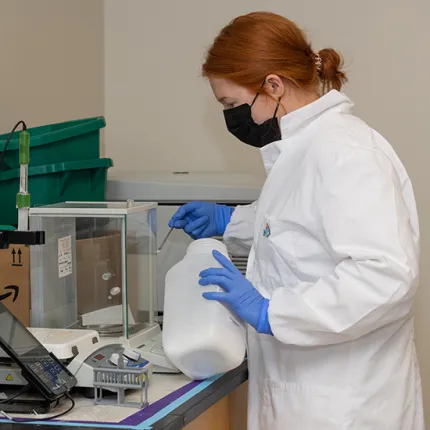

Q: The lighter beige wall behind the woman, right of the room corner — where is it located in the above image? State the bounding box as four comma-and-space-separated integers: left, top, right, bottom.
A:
105, 0, 430, 422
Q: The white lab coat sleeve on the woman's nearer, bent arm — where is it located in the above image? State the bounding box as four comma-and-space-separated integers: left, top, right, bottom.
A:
269, 145, 419, 346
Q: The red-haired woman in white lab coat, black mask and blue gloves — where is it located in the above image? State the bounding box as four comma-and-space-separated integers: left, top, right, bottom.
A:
170, 12, 424, 430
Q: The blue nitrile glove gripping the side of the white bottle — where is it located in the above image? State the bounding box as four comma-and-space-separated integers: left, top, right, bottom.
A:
199, 251, 273, 335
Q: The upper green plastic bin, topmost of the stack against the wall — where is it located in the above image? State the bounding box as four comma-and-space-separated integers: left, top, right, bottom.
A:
0, 117, 106, 171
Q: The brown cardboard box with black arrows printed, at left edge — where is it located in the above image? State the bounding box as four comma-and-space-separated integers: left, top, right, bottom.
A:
0, 245, 30, 327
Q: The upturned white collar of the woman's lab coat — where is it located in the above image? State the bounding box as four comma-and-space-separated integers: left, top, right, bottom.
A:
261, 90, 354, 174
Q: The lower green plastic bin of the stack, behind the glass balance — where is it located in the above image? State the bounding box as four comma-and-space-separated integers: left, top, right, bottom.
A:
0, 158, 113, 226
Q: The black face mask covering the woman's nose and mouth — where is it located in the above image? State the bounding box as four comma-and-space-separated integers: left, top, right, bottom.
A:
224, 93, 281, 148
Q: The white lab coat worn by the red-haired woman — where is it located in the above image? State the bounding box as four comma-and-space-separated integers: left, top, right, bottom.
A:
224, 91, 424, 430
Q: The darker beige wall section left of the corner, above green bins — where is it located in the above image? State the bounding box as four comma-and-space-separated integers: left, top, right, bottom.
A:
0, 0, 104, 136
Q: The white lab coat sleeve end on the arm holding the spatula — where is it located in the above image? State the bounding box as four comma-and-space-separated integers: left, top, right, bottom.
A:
224, 202, 257, 257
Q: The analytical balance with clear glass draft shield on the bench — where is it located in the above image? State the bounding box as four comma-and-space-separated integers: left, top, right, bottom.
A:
26, 201, 177, 376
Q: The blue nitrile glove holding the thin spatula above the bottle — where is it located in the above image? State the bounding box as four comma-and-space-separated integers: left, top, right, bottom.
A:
169, 202, 234, 239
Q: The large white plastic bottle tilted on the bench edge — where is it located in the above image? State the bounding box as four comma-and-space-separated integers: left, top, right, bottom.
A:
163, 239, 246, 380
